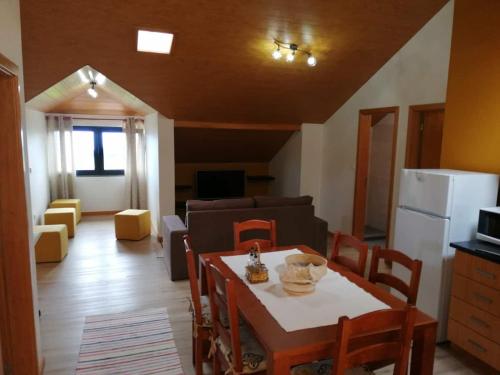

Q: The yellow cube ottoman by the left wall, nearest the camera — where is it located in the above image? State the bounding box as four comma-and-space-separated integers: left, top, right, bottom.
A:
33, 224, 68, 263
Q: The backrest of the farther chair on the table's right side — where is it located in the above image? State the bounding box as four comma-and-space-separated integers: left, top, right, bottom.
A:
331, 232, 368, 277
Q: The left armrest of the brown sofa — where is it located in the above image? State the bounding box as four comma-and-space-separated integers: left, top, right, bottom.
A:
163, 215, 188, 281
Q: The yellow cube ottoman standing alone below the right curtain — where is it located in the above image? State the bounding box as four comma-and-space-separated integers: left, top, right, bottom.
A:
115, 210, 151, 240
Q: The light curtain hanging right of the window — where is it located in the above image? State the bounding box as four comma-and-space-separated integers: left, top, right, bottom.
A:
124, 117, 147, 209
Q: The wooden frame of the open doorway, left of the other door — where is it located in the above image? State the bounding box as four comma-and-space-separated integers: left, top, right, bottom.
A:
352, 107, 399, 246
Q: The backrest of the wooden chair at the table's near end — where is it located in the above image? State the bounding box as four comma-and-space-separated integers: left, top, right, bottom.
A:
333, 305, 416, 375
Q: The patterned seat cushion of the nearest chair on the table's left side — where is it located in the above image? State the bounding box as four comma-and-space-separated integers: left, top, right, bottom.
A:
217, 326, 267, 374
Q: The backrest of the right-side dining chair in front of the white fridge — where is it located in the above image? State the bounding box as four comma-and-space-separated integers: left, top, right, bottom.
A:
368, 246, 422, 305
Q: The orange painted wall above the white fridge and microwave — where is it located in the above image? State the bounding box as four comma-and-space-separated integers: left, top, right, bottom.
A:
441, 0, 500, 173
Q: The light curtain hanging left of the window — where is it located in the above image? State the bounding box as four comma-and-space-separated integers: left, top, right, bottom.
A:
47, 115, 75, 200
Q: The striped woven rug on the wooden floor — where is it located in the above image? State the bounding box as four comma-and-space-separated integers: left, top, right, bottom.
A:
76, 308, 183, 375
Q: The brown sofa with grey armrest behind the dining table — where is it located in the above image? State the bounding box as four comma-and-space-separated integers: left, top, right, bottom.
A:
163, 196, 328, 280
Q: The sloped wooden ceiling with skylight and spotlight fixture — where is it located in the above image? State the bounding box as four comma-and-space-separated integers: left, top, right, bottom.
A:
21, 0, 447, 123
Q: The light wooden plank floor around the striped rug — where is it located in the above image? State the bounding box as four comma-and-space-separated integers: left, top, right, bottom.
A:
37, 216, 489, 375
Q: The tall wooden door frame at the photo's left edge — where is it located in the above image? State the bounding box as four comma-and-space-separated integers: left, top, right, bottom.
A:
0, 54, 41, 374
